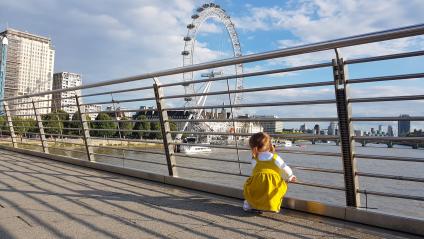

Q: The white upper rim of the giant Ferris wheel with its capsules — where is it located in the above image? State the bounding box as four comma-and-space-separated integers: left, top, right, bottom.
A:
182, 3, 243, 104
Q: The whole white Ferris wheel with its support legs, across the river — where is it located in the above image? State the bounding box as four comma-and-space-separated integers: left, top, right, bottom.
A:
181, 3, 243, 137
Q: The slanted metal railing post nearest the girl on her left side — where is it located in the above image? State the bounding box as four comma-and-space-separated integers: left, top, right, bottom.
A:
153, 78, 178, 177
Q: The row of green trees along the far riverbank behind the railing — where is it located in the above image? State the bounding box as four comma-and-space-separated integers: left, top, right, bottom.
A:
0, 110, 177, 139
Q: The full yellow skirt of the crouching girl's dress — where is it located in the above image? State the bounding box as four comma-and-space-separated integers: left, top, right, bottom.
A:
243, 172, 287, 212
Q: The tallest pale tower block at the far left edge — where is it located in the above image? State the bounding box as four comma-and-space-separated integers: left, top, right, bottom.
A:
0, 28, 55, 116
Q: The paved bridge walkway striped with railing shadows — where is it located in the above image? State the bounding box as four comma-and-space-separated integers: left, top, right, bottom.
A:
0, 150, 417, 239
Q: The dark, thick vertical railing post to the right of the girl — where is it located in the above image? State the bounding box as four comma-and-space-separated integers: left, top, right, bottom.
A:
332, 49, 360, 207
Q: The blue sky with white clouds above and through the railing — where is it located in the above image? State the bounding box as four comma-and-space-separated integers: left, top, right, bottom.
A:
0, 0, 424, 132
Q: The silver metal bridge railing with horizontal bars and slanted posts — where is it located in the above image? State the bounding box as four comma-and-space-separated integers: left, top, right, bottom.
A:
0, 24, 424, 222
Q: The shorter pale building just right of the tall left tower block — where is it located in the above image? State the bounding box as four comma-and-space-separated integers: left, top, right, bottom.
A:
52, 72, 82, 117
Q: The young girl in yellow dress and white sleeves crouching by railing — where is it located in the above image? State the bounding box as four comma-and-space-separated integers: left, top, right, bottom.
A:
243, 133, 296, 212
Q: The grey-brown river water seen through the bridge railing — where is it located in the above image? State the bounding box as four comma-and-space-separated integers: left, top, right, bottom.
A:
38, 142, 424, 220
